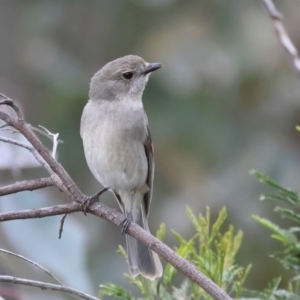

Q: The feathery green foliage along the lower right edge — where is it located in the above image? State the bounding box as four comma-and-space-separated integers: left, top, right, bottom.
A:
250, 170, 300, 299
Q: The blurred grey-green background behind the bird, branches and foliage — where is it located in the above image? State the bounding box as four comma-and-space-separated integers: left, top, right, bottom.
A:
0, 0, 300, 299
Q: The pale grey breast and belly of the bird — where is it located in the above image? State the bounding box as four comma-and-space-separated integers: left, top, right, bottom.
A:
82, 101, 148, 190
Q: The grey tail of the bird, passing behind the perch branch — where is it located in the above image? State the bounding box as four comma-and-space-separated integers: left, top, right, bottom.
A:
126, 201, 163, 280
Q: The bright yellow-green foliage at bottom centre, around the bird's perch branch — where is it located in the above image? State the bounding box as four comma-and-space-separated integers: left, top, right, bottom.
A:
99, 207, 251, 300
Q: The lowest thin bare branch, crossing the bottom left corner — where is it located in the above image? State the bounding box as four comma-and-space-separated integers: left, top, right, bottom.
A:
0, 275, 99, 300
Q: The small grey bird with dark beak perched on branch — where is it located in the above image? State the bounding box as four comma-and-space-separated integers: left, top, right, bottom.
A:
80, 55, 163, 280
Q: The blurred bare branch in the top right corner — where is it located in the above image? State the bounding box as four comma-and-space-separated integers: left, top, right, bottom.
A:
263, 0, 300, 76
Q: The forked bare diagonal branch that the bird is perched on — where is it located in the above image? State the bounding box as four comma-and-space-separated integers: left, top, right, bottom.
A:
0, 94, 231, 300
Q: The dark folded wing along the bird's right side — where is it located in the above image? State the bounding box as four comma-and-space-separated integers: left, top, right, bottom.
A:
144, 126, 154, 217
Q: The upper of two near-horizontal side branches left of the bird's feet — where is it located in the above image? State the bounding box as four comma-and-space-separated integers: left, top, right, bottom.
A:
0, 177, 54, 196
